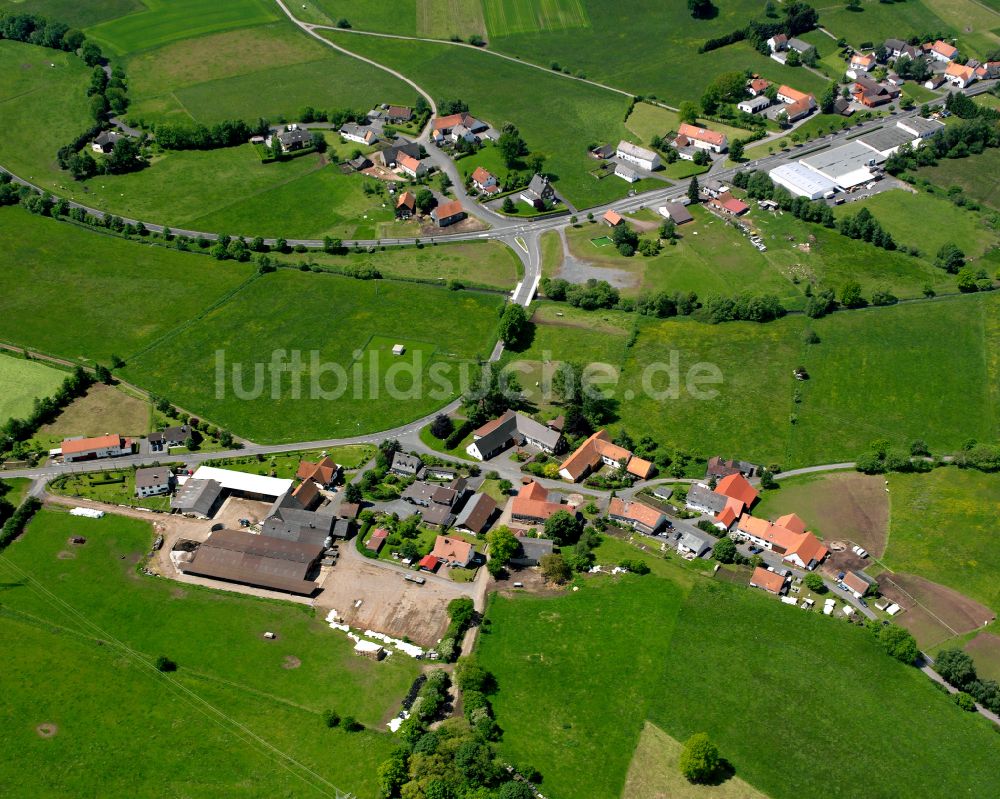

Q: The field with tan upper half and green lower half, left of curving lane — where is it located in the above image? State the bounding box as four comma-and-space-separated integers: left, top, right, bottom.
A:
126, 20, 414, 124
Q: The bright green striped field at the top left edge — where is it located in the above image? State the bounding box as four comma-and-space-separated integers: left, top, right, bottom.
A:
86, 0, 281, 55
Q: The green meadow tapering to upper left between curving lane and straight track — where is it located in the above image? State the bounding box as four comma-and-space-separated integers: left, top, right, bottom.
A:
325, 31, 629, 207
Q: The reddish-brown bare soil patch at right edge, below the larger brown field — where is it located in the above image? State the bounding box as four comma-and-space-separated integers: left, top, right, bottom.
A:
878, 572, 996, 647
